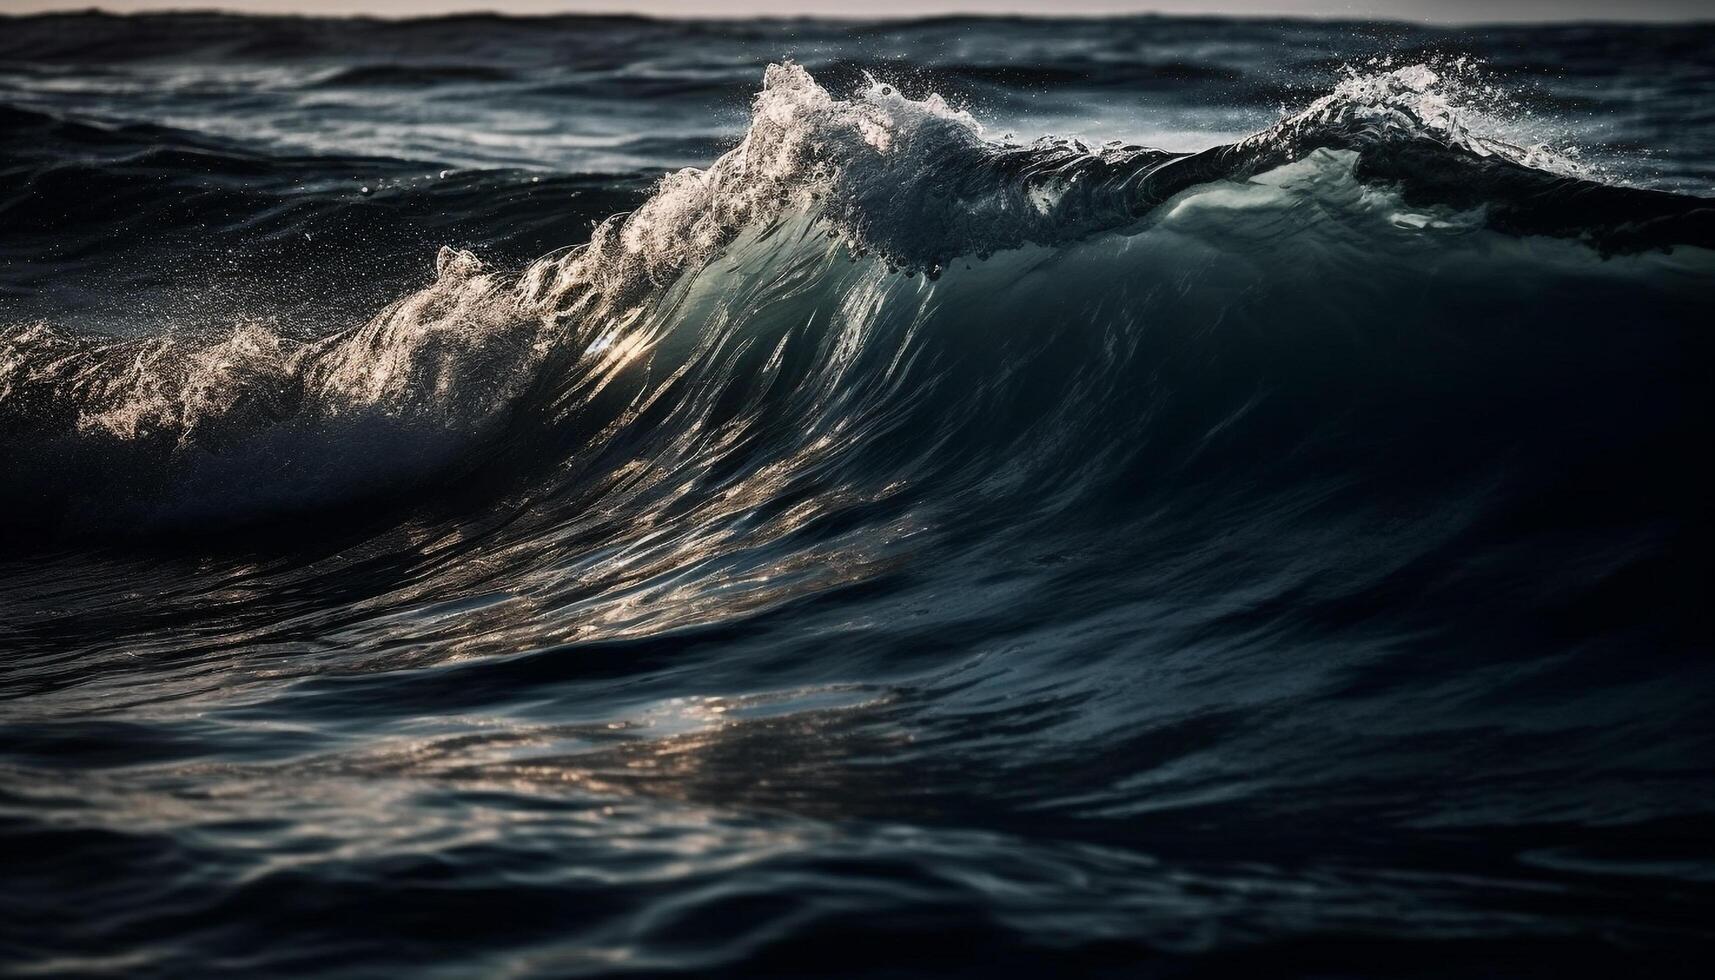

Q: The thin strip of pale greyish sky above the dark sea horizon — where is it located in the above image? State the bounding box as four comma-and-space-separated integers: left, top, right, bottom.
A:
0, 0, 1715, 24
